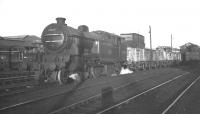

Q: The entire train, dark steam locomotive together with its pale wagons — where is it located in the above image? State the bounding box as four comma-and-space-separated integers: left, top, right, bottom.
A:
39, 18, 181, 84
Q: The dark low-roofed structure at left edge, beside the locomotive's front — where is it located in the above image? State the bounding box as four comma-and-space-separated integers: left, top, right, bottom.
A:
0, 35, 43, 71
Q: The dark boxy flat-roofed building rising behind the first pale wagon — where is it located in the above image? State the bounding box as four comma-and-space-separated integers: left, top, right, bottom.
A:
120, 33, 145, 48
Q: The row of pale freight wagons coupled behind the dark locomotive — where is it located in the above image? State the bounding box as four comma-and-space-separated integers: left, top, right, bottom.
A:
127, 47, 181, 71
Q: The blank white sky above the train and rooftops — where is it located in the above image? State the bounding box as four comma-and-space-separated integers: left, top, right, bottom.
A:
0, 0, 200, 48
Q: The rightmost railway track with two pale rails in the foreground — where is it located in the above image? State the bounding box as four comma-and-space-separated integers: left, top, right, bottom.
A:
95, 70, 200, 114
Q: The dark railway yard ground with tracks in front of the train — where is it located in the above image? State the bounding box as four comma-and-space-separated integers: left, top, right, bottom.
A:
0, 65, 200, 114
